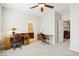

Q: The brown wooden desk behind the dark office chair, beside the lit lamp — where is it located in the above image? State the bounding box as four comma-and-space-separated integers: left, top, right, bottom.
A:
5, 33, 34, 49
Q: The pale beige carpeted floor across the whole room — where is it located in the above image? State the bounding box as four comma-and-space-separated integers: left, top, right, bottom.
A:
0, 40, 79, 56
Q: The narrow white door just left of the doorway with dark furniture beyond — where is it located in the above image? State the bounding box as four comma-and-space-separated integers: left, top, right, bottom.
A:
58, 20, 64, 42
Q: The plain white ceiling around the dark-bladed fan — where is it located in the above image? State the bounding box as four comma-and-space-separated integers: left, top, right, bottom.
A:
1, 3, 70, 16
